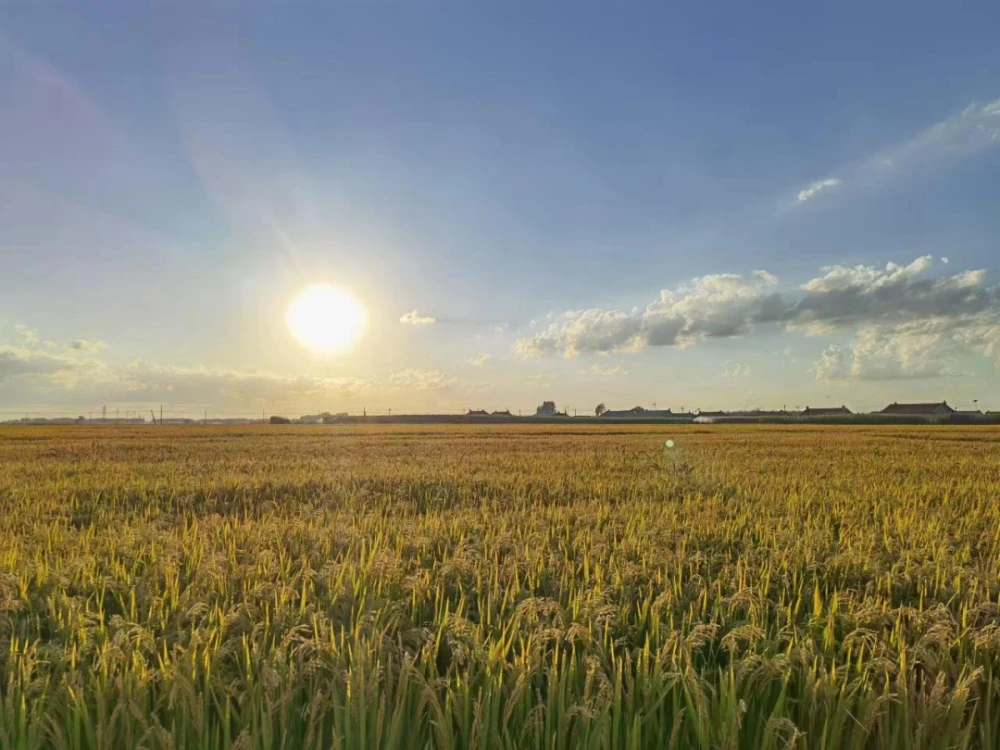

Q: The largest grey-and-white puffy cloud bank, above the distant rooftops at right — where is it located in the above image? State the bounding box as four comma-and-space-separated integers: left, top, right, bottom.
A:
514, 255, 1000, 380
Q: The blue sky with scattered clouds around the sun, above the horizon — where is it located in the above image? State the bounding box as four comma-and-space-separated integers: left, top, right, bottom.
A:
0, 0, 1000, 420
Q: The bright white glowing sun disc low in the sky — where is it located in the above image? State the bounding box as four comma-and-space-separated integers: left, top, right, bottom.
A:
285, 284, 367, 354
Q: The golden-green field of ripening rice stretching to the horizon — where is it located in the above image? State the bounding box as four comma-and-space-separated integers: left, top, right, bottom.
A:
0, 425, 1000, 750
